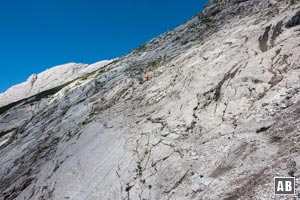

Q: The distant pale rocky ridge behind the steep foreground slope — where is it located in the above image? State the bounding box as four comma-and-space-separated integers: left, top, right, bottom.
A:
0, 60, 111, 106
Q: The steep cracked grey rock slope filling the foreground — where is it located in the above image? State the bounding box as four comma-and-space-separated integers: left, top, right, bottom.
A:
0, 0, 300, 200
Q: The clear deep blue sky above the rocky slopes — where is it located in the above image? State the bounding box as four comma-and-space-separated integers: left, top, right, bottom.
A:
0, 0, 206, 92
